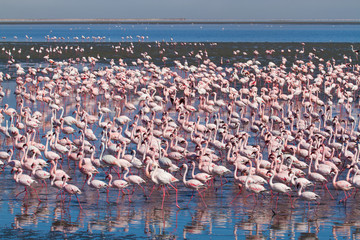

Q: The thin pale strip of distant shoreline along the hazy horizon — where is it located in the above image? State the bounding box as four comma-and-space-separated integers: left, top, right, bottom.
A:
0, 18, 360, 24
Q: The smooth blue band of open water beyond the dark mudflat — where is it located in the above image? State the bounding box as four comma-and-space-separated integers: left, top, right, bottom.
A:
0, 24, 360, 42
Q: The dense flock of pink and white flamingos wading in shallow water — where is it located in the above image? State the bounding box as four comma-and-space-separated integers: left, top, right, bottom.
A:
0, 41, 360, 212
